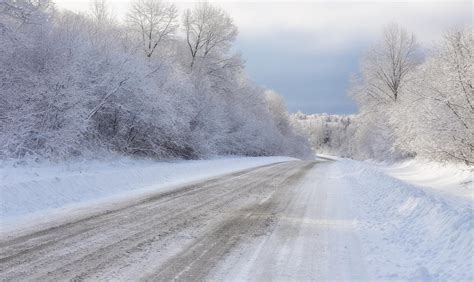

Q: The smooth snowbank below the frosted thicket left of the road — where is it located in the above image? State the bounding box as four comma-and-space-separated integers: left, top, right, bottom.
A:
0, 157, 294, 225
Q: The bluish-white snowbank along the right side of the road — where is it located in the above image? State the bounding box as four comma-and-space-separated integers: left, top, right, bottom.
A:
334, 160, 474, 281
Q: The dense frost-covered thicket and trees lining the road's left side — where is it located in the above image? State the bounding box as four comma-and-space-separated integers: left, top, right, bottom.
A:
0, 0, 311, 159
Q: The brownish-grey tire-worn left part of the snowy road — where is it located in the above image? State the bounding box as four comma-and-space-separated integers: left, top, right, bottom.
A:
0, 161, 316, 281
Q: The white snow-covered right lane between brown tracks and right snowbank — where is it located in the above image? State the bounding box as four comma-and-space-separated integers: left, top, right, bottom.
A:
213, 162, 368, 281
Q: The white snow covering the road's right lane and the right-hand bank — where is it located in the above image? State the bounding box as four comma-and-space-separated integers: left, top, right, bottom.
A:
213, 159, 474, 281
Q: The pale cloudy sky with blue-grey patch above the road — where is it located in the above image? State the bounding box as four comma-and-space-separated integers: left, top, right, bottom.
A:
55, 0, 473, 114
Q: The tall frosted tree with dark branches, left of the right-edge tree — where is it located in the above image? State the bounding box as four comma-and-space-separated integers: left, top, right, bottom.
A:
350, 24, 420, 162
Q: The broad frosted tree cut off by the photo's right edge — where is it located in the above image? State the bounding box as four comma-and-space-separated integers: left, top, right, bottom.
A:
391, 27, 474, 164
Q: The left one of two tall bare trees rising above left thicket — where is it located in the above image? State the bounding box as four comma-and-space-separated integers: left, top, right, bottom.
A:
127, 0, 178, 57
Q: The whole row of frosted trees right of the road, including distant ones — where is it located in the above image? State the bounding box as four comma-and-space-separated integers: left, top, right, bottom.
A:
293, 24, 474, 165
